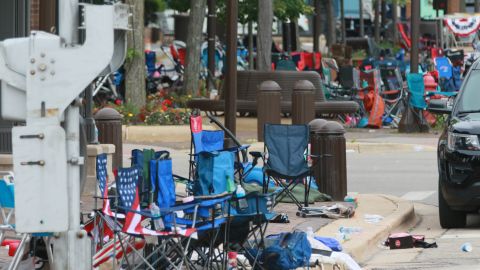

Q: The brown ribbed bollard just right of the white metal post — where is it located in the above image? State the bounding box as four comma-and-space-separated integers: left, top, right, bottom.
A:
95, 108, 123, 169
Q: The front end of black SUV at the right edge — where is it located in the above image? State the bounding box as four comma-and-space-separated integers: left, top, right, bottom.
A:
429, 61, 480, 228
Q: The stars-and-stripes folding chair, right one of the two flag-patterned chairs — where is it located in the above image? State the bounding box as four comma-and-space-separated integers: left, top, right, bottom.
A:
116, 167, 198, 270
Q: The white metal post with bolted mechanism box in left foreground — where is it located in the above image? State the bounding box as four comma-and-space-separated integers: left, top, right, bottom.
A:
0, 0, 129, 270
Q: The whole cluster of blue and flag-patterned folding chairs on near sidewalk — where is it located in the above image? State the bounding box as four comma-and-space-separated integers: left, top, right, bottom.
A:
85, 112, 315, 269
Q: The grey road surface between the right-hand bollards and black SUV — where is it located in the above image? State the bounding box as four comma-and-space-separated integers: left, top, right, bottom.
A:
347, 148, 480, 270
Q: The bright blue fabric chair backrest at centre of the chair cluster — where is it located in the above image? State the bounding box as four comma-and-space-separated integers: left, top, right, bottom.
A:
194, 151, 235, 196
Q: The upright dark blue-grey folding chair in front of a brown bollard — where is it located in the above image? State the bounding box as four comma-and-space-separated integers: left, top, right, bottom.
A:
251, 124, 315, 215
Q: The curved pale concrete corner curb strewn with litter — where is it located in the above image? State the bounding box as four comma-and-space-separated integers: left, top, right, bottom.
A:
316, 195, 415, 263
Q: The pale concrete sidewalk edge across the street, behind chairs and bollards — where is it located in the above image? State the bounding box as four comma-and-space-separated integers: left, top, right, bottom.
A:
122, 117, 438, 152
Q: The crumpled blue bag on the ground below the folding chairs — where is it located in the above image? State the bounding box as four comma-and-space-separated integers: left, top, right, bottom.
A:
261, 231, 312, 270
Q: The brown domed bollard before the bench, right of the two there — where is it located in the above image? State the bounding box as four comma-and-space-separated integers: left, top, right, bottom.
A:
292, 80, 315, 125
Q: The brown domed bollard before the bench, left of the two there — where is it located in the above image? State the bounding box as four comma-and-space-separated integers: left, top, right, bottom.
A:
257, 81, 282, 142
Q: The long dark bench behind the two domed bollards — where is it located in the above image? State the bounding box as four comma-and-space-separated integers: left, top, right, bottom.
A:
187, 71, 359, 116
